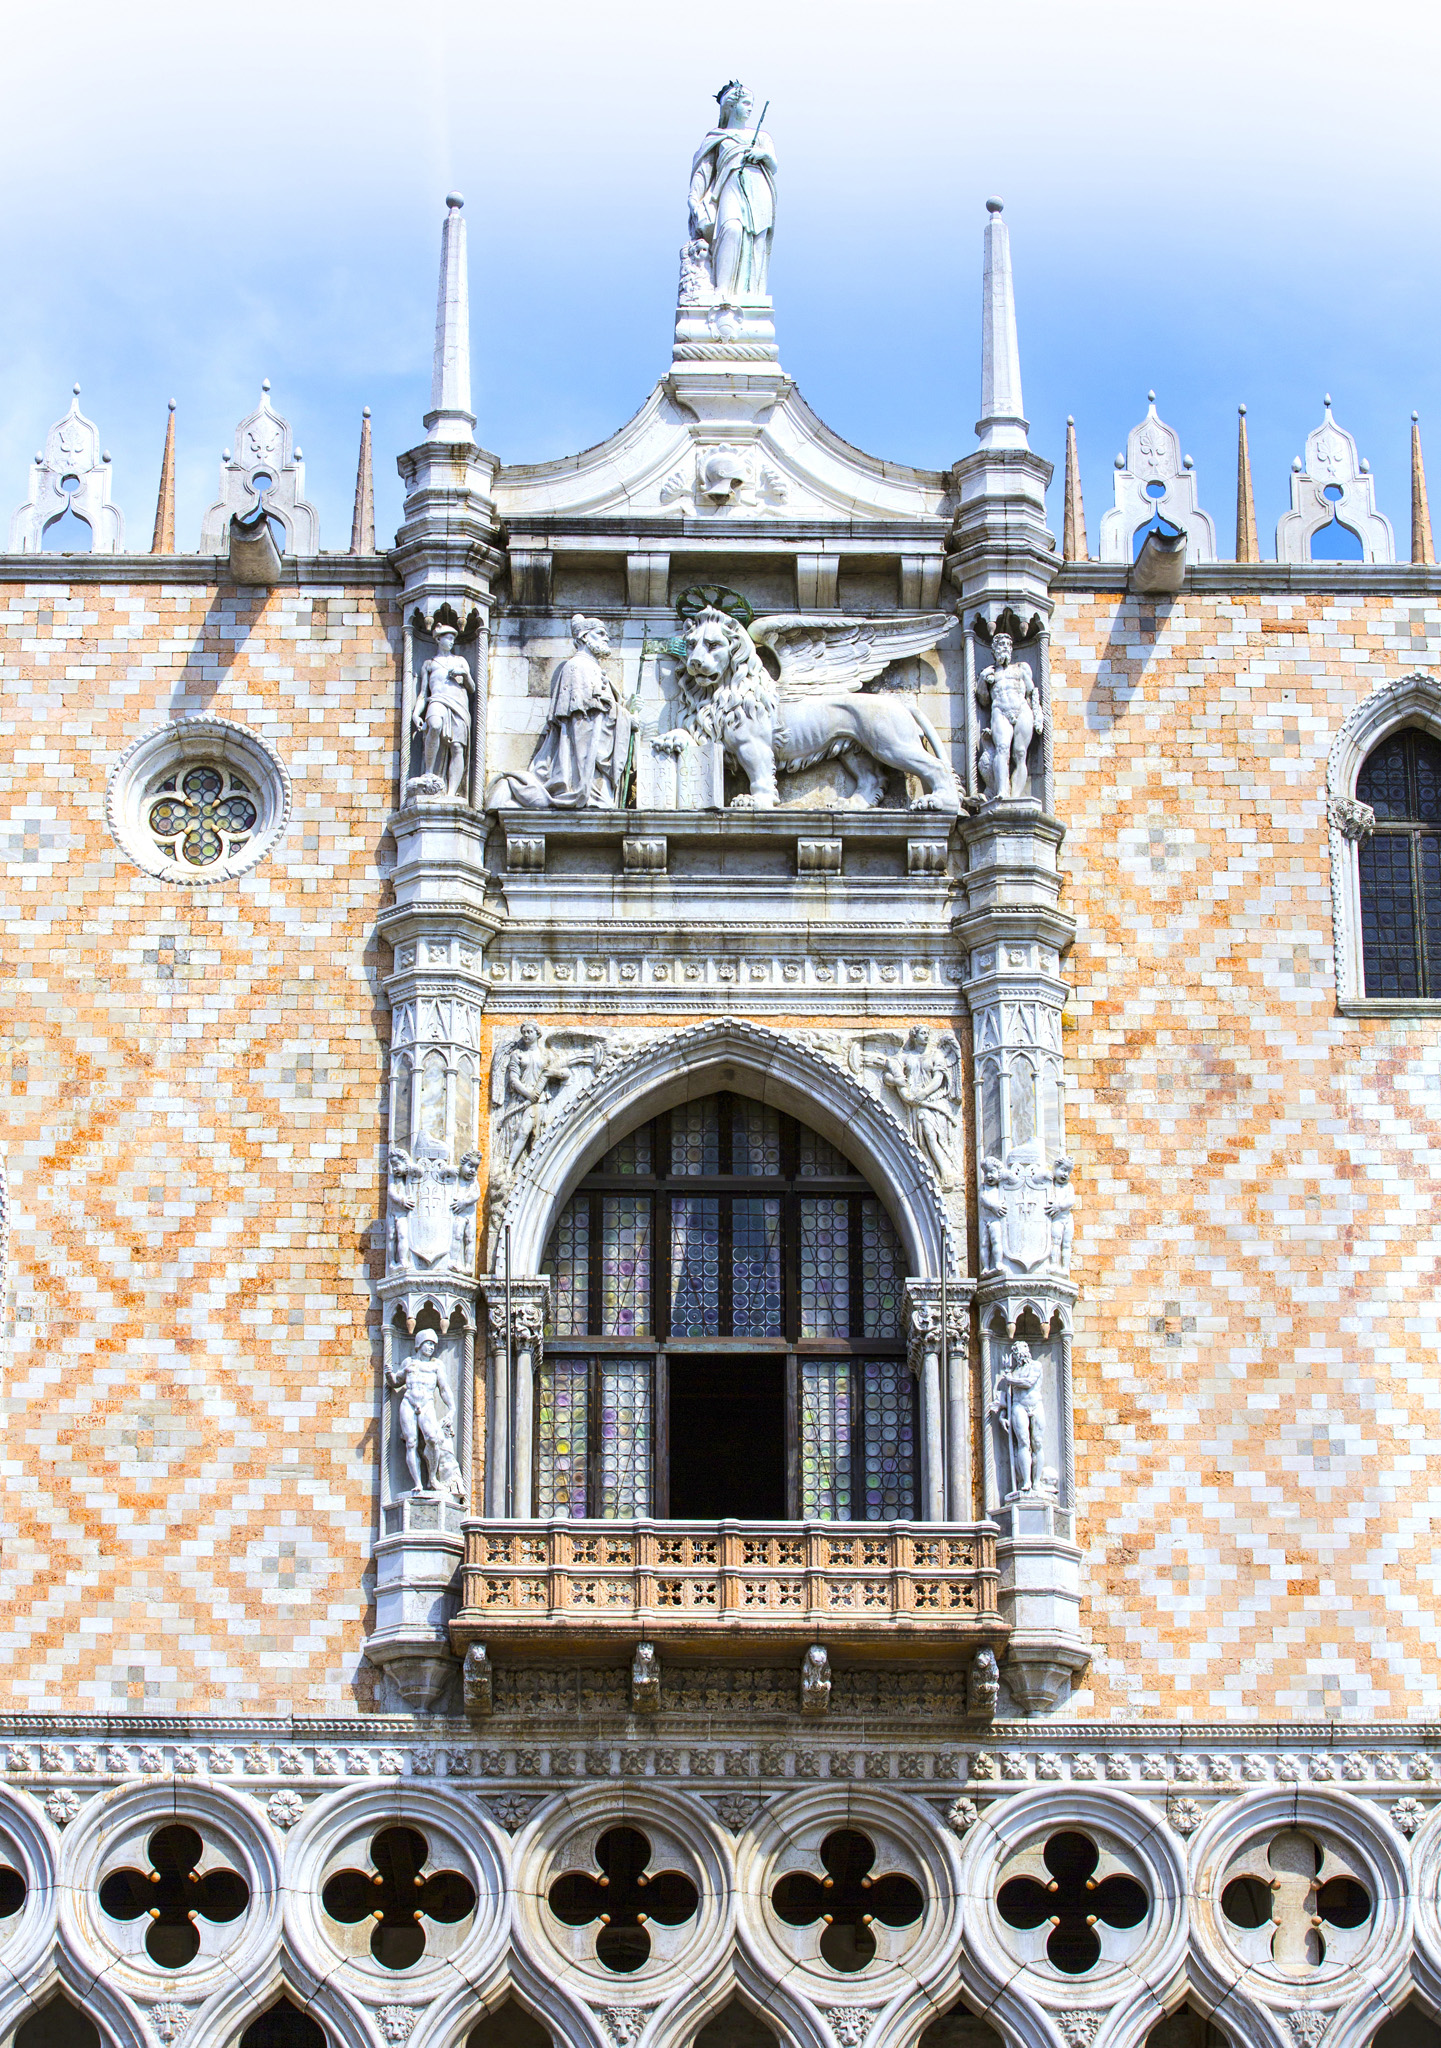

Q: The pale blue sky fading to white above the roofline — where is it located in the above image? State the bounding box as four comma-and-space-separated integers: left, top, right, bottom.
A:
0, 0, 1441, 555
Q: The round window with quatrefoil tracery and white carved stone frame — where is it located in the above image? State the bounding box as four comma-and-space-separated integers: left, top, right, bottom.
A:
106, 719, 291, 883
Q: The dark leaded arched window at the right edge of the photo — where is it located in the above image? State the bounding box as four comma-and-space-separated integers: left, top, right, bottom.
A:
1355, 727, 1441, 997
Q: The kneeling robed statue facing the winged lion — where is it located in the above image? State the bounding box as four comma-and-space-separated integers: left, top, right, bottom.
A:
485, 612, 630, 811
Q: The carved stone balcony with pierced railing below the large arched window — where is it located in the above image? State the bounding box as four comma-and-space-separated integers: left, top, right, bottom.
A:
450, 1520, 1009, 1663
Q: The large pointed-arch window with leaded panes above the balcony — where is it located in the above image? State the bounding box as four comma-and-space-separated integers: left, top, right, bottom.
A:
532, 1094, 917, 1522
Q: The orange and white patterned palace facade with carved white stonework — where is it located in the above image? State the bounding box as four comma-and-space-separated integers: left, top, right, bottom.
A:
0, 82, 1441, 2048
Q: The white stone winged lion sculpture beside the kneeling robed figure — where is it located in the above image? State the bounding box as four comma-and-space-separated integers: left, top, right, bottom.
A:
680, 606, 960, 811
